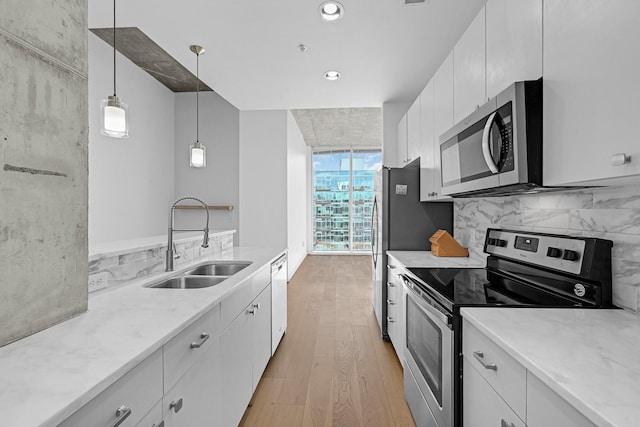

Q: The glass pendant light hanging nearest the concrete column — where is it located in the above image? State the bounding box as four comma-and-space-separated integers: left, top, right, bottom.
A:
100, 0, 129, 138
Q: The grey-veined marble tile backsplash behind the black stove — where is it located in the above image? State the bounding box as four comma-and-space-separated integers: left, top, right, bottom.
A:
454, 187, 640, 313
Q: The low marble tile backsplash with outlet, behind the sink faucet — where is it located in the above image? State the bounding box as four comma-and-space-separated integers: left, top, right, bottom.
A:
89, 233, 233, 286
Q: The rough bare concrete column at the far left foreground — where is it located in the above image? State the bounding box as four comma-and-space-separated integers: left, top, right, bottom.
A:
0, 0, 88, 345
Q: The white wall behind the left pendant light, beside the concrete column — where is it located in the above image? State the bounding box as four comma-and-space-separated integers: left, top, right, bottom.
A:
89, 32, 175, 248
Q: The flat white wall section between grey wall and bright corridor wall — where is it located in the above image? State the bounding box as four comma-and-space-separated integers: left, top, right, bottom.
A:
239, 110, 287, 249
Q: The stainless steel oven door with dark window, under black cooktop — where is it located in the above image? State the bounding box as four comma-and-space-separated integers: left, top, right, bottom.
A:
404, 279, 453, 427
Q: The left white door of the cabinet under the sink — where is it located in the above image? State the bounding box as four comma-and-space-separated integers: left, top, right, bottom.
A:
220, 307, 253, 426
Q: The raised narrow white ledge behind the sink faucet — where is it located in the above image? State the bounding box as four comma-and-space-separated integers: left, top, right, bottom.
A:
89, 230, 236, 259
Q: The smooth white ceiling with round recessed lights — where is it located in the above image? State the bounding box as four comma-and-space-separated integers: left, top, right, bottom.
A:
89, 0, 486, 110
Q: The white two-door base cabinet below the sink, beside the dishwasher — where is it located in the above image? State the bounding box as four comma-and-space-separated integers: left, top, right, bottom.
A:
220, 285, 271, 426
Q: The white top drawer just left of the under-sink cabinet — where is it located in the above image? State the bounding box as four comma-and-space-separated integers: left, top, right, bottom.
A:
163, 305, 220, 390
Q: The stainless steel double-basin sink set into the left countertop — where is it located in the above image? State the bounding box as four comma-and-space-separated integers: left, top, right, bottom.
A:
147, 261, 251, 289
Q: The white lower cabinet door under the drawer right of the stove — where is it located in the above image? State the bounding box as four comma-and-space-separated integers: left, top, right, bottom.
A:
462, 357, 528, 427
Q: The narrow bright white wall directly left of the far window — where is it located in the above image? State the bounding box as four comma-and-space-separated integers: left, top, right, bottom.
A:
287, 111, 311, 279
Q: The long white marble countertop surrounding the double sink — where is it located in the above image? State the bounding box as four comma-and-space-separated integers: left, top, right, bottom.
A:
0, 247, 285, 427
